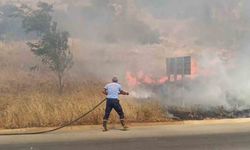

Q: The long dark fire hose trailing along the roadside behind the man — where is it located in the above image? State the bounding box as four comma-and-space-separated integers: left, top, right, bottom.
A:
0, 99, 106, 136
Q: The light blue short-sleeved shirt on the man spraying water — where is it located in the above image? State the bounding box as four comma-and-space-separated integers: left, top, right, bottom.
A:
104, 82, 122, 99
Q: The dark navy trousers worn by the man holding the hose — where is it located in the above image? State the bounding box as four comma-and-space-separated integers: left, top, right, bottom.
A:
103, 99, 124, 121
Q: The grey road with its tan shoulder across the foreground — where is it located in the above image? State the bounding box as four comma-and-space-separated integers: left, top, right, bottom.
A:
0, 119, 250, 150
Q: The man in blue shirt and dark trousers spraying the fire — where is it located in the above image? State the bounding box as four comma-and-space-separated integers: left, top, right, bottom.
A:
103, 77, 129, 131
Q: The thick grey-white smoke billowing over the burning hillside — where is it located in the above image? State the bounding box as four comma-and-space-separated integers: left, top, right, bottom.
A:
1, 0, 250, 108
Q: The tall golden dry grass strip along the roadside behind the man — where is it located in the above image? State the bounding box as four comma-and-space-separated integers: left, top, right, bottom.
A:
0, 81, 168, 128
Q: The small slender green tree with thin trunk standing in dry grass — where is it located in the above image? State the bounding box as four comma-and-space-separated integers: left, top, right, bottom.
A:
27, 23, 73, 93
